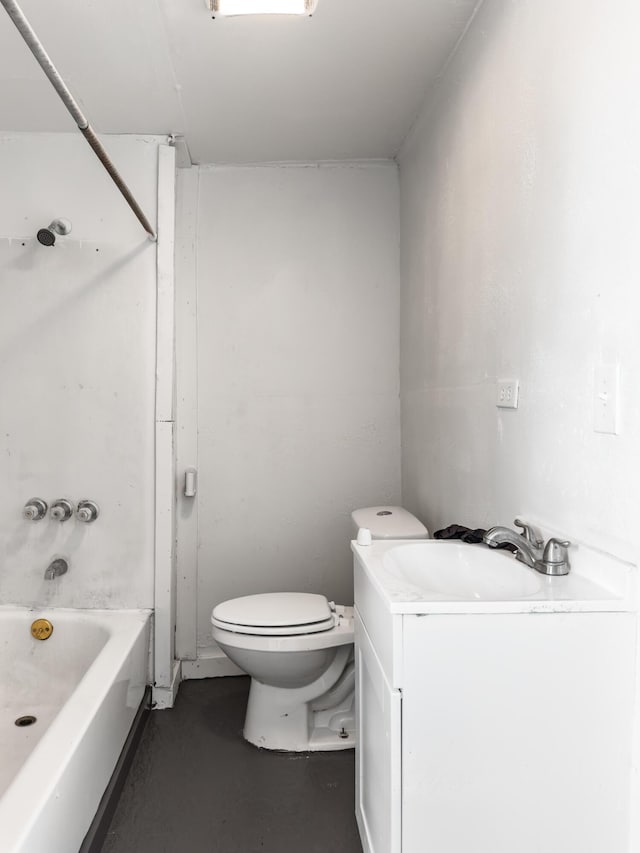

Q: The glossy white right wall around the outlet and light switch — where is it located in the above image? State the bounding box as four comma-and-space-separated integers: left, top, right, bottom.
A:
400, 0, 640, 560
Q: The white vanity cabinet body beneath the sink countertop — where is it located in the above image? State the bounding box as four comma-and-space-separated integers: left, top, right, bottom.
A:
354, 548, 637, 853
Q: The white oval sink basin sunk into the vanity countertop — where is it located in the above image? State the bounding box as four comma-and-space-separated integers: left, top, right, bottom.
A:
382, 542, 543, 601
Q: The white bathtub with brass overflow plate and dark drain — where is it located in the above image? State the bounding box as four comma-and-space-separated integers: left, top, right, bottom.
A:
0, 607, 150, 853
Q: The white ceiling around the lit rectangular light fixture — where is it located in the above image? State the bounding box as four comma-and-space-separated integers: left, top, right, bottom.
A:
0, 0, 478, 163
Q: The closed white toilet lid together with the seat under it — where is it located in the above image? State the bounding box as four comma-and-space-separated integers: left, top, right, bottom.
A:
211, 592, 336, 636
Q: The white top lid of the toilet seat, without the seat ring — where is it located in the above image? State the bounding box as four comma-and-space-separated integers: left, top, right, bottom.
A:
212, 592, 333, 628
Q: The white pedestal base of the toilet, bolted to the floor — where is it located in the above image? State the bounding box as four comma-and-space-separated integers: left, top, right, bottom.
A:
243, 678, 355, 752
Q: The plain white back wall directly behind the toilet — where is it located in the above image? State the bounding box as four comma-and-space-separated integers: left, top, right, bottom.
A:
197, 163, 400, 646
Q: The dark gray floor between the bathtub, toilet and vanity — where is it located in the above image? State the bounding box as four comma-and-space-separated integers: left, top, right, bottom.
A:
102, 677, 362, 853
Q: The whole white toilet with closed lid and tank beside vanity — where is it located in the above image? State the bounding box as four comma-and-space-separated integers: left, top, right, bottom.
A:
211, 506, 429, 752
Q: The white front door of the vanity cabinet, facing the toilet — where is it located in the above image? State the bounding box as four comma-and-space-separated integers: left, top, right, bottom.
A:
355, 611, 402, 853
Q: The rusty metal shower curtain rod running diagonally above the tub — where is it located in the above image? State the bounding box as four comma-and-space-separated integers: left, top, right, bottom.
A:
0, 0, 157, 240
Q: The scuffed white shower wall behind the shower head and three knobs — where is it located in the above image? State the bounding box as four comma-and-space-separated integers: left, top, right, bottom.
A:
0, 134, 161, 607
